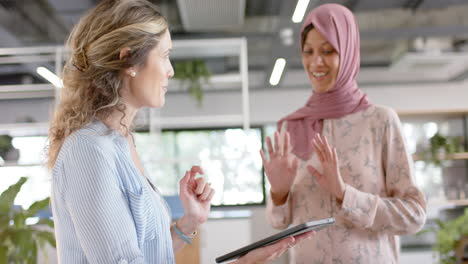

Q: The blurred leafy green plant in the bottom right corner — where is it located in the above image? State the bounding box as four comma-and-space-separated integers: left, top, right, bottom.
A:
418, 208, 468, 264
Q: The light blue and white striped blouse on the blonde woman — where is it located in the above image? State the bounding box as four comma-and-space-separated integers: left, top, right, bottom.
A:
51, 121, 175, 264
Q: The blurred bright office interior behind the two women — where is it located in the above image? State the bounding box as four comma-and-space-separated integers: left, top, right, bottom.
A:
0, 0, 468, 263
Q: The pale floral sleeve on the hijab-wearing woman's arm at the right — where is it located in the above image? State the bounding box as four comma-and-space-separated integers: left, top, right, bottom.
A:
341, 111, 426, 235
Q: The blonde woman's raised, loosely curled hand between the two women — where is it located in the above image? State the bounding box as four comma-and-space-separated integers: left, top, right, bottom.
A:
177, 166, 215, 232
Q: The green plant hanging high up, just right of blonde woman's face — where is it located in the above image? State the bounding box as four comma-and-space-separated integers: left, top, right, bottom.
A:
174, 60, 211, 106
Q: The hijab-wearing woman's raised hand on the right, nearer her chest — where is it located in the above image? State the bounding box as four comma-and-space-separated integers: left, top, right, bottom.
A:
307, 134, 346, 202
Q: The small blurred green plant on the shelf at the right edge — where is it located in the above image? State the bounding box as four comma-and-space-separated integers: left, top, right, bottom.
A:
423, 132, 463, 166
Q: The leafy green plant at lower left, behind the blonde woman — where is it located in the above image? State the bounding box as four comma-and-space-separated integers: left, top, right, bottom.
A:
0, 177, 55, 264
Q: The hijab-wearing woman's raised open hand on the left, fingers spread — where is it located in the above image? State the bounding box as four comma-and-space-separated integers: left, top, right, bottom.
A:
260, 132, 297, 204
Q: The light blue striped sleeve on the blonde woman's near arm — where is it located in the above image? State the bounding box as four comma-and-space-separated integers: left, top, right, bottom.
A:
64, 138, 144, 264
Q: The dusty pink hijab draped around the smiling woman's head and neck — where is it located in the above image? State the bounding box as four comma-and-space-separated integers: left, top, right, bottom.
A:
278, 4, 370, 160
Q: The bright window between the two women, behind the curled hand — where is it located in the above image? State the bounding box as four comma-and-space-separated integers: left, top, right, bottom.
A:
135, 128, 264, 206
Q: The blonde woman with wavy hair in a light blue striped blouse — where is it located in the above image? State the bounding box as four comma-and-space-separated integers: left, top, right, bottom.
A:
48, 0, 310, 264
